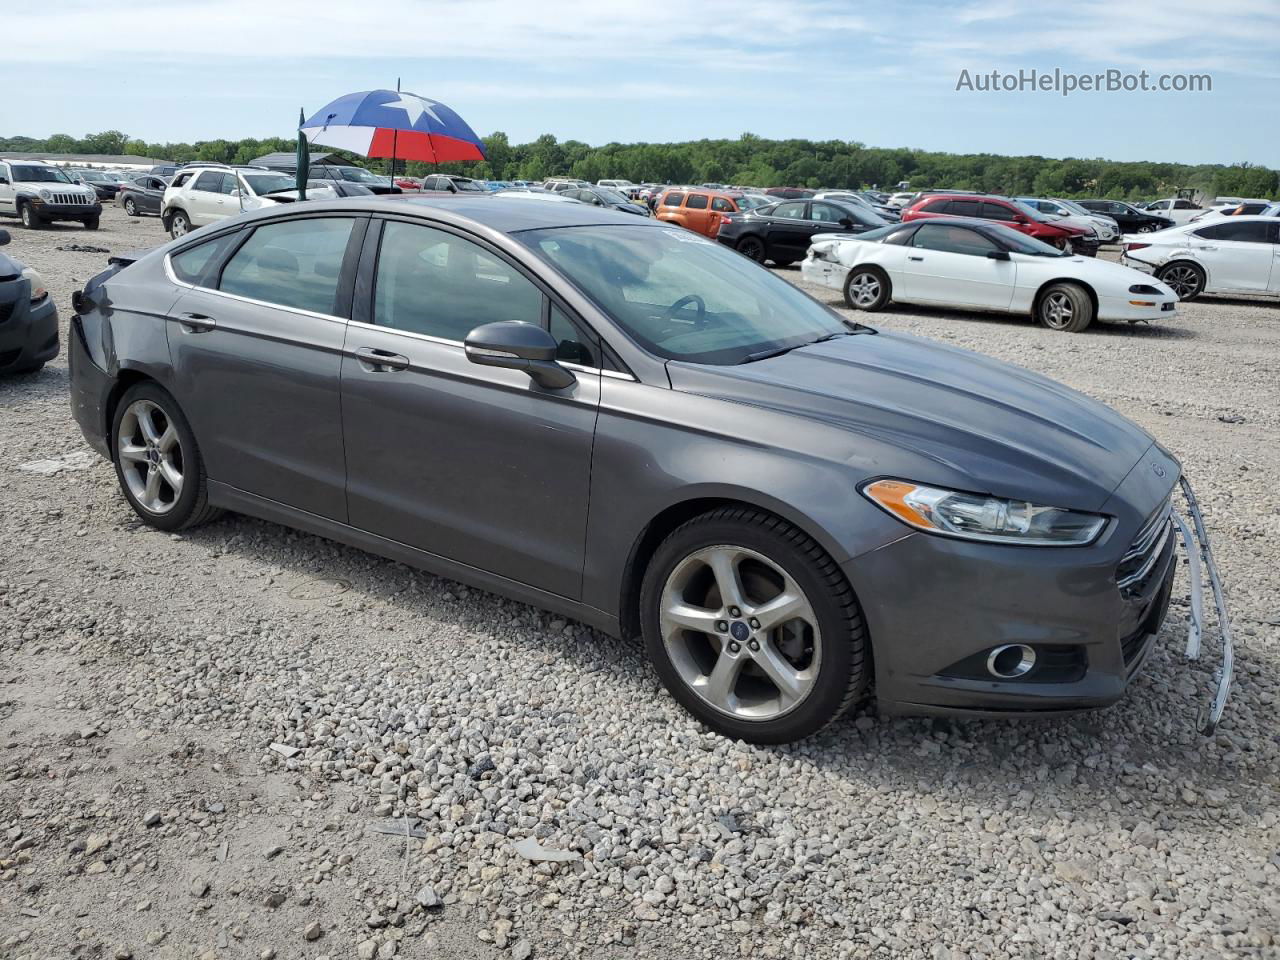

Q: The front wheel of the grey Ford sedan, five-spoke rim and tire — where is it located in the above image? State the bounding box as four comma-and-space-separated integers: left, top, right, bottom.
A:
640, 507, 869, 744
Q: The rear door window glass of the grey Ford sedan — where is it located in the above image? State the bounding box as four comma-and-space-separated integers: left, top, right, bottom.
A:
218, 216, 355, 316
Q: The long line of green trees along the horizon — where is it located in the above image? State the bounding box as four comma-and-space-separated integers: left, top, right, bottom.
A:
0, 131, 1280, 200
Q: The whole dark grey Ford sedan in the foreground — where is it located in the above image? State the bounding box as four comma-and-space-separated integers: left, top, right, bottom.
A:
70, 195, 1230, 742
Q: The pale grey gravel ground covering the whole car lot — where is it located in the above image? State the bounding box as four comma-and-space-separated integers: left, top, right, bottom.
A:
0, 207, 1280, 960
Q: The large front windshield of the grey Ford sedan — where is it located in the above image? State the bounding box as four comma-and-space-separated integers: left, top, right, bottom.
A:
515, 225, 850, 365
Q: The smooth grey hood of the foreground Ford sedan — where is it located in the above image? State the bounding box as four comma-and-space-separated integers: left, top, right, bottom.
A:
667, 330, 1155, 511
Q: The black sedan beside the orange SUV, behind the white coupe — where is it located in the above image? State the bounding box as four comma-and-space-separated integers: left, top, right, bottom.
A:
716, 200, 887, 266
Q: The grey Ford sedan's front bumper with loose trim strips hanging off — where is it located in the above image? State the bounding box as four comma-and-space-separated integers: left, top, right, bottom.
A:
844, 463, 1233, 732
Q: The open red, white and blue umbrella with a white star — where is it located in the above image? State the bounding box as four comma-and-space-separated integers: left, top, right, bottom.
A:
300, 90, 485, 164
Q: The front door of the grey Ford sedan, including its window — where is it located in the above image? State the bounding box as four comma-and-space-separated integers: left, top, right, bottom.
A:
342, 220, 600, 599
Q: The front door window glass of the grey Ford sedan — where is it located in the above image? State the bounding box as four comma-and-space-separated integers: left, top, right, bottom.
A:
374, 220, 543, 342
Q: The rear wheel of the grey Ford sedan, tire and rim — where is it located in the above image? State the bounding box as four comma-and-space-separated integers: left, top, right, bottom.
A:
111, 383, 221, 530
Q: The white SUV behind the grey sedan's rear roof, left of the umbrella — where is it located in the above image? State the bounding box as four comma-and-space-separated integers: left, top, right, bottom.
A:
160, 164, 310, 237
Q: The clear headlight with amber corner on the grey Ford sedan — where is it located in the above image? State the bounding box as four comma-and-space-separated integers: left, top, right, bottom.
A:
861, 480, 1107, 547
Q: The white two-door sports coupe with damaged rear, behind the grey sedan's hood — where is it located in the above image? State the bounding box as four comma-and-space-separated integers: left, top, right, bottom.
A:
800, 216, 1178, 333
